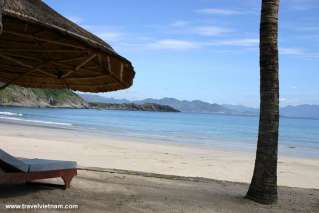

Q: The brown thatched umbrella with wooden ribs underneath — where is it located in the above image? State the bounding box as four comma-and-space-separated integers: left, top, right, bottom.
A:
0, 0, 135, 92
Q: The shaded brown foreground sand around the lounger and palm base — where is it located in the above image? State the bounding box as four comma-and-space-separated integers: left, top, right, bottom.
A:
0, 170, 319, 213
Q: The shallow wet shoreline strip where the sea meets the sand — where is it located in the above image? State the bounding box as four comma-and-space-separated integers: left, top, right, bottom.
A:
0, 116, 319, 160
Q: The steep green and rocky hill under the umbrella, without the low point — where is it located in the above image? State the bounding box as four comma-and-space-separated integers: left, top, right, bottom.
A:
0, 86, 88, 108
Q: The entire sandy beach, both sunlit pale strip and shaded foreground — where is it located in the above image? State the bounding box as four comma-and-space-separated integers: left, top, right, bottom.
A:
0, 121, 319, 213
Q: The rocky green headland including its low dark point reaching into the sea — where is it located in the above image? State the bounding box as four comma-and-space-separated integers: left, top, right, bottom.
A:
0, 85, 179, 112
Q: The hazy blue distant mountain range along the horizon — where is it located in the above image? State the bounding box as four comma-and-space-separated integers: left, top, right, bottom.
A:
79, 94, 319, 119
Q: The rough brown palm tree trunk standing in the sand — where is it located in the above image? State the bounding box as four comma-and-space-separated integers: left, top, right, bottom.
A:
246, 0, 279, 204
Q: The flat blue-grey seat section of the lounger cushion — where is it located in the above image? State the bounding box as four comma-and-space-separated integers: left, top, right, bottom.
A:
22, 159, 77, 172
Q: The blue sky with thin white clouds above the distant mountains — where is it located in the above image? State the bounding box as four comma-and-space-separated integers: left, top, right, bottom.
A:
45, 0, 319, 107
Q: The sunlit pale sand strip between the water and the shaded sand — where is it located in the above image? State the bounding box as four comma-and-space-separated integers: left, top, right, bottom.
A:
0, 120, 319, 189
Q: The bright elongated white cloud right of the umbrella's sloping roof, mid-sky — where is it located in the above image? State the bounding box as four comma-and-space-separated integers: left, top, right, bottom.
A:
148, 39, 201, 50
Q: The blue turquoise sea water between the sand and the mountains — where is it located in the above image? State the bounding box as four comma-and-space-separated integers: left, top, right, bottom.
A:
0, 107, 319, 157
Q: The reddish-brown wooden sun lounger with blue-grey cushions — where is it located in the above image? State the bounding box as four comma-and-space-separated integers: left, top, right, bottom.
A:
0, 149, 77, 189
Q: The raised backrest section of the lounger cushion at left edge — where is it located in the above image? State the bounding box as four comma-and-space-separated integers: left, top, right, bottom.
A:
0, 149, 29, 172
